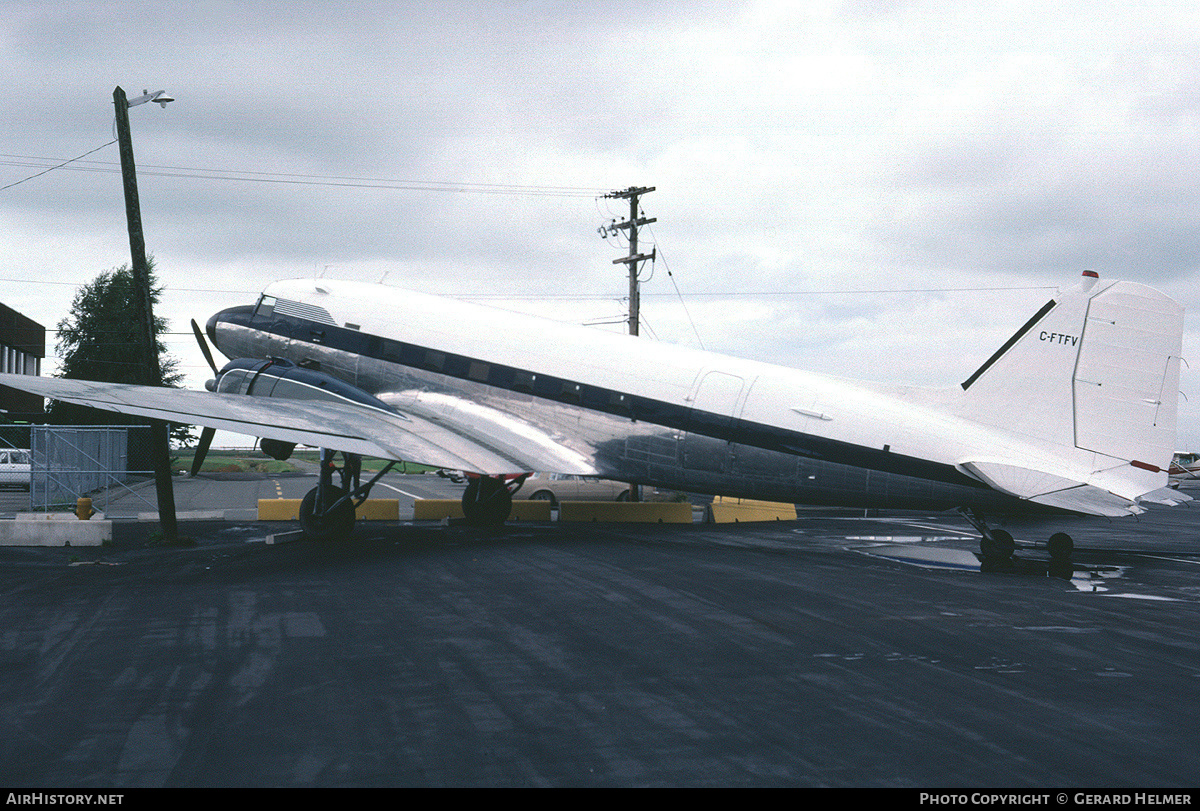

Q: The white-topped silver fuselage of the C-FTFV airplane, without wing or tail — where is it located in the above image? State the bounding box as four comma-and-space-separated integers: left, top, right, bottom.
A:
206, 280, 1036, 507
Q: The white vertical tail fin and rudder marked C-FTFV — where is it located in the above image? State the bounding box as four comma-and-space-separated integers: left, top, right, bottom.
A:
961, 272, 1183, 473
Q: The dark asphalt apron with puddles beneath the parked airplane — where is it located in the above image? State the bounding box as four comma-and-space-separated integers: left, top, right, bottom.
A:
0, 477, 1200, 789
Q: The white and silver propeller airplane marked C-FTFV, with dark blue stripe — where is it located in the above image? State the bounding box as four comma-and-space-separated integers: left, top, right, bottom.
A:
0, 271, 1190, 559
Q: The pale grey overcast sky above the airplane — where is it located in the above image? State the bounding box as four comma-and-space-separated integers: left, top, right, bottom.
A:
0, 0, 1200, 449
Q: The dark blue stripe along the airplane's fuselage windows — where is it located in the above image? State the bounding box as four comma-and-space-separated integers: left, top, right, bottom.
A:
220, 302, 988, 489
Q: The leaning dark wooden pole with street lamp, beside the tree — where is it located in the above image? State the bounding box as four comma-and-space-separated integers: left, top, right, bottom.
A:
113, 88, 179, 543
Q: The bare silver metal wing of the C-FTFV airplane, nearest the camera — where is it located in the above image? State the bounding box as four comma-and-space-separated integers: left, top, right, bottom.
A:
0, 374, 595, 475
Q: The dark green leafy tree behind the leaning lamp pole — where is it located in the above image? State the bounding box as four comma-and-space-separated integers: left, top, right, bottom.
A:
47, 257, 191, 441
